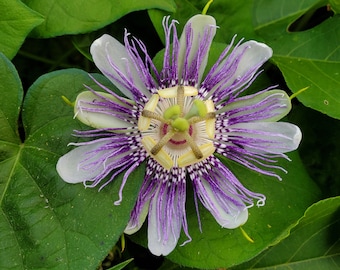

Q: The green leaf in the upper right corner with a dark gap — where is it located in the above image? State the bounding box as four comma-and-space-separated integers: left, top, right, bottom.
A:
254, 0, 340, 119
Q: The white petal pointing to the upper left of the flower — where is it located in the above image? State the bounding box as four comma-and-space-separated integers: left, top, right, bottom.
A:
90, 34, 150, 99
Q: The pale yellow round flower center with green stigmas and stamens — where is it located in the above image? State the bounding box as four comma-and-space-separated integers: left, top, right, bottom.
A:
138, 85, 215, 170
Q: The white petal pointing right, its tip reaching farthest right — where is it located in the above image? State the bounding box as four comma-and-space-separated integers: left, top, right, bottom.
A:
229, 122, 302, 154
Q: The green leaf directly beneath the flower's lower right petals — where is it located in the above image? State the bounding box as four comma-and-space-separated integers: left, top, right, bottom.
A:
163, 154, 318, 269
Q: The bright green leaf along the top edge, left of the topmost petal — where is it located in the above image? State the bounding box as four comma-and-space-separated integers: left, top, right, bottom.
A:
23, 0, 175, 38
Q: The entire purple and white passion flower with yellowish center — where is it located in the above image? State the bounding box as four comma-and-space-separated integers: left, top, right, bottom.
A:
57, 15, 301, 255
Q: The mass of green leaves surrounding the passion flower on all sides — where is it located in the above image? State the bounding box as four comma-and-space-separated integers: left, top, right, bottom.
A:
0, 0, 340, 270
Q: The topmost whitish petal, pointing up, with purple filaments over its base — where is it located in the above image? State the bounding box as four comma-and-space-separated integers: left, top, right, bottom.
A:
178, 14, 216, 82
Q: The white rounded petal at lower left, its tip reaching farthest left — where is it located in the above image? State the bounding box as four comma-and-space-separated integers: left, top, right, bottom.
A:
57, 142, 104, 184
